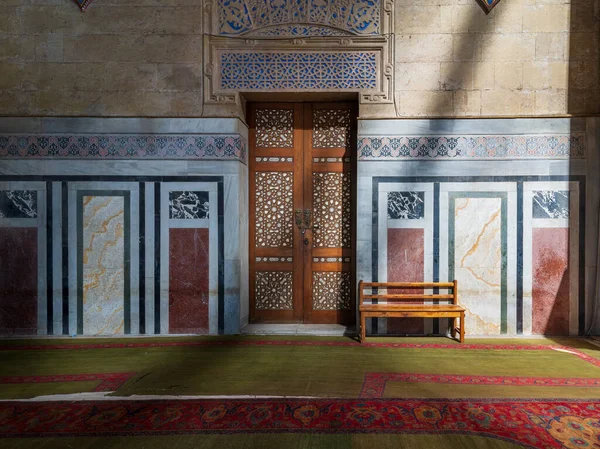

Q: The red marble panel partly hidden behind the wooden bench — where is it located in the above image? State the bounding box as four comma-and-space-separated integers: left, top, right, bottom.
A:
387, 229, 425, 334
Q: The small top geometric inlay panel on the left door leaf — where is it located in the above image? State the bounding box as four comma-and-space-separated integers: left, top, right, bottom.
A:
256, 109, 294, 148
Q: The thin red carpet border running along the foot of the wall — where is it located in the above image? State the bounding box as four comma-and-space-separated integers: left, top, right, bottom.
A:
0, 340, 600, 368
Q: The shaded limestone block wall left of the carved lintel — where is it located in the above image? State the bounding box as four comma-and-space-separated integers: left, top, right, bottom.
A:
0, 0, 203, 117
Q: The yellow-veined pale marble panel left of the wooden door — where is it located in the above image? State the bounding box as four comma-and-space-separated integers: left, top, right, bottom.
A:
82, 196, 128, 335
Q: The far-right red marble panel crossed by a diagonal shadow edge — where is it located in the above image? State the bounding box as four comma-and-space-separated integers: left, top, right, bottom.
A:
532, 228, 569, 335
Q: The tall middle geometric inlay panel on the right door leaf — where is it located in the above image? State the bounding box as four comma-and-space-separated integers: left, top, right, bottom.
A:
313, 172, 351, 248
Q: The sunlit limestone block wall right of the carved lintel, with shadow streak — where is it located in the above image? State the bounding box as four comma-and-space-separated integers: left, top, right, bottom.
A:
395, 0, 600, 117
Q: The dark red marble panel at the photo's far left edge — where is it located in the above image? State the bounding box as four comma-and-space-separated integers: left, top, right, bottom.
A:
0, 228, 38, 335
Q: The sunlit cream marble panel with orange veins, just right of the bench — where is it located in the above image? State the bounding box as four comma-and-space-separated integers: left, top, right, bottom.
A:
449, 198, 506, 335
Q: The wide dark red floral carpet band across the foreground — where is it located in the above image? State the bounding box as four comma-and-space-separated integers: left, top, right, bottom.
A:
0, 399, 600, 448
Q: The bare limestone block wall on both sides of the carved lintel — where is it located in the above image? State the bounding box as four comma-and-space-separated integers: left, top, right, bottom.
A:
0, 0, 600, 117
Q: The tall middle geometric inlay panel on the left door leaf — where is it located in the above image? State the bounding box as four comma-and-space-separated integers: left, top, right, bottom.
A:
255, 172, 294, 248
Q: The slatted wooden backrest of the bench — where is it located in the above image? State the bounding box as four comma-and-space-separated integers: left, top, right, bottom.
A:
358, 280, 458, 305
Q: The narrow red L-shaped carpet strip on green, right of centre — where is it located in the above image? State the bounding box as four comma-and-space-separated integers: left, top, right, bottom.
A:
359, 373, 600, 398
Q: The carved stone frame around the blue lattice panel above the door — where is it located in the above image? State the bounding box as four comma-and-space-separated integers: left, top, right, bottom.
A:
203, 0, 395, 119
